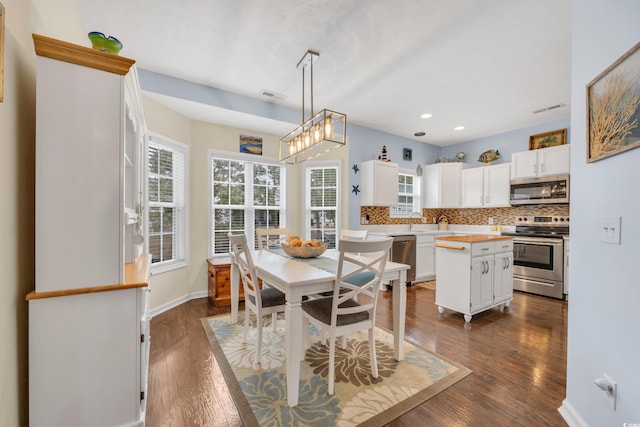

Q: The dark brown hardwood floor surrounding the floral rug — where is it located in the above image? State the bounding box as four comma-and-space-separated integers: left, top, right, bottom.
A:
147, 286, 567, 427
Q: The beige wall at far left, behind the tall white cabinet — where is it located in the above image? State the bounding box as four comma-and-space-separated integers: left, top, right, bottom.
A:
0, 0, 89, 426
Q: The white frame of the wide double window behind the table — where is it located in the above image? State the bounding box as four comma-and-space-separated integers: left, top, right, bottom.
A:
206, 149, 287, 258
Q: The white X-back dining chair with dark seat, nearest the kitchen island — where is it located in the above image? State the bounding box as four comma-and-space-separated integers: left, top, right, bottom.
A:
302, 238, 393, 394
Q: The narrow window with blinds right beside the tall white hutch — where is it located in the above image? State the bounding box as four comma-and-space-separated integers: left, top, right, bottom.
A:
148, 135, 188, 268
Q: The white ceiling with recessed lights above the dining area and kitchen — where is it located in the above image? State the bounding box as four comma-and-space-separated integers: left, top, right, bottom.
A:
77, 0, 571, 146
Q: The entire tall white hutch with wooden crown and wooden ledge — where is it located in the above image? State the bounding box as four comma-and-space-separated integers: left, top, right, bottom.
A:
26, 34, 150, 426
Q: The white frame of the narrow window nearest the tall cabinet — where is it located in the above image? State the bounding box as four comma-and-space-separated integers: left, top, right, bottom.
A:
144, 132, 190, 275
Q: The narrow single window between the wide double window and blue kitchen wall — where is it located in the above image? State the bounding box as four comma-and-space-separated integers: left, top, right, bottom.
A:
305, 164, 339, 248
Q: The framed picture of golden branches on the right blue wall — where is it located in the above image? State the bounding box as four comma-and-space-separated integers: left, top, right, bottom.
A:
587, 42, 640, 163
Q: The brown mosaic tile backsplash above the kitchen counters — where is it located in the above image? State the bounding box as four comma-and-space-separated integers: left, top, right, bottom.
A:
360, 205, 569, 225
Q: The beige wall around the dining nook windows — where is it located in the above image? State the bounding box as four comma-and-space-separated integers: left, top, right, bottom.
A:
144, 97, 349, 311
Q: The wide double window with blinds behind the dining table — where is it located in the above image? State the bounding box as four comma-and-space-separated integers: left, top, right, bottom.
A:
210, 154, 285, 255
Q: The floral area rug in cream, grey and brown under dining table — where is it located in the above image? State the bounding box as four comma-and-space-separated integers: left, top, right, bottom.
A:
202, 312, 471, 427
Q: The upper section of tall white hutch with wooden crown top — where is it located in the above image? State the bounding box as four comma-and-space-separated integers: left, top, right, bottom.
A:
33, 34, 147, 292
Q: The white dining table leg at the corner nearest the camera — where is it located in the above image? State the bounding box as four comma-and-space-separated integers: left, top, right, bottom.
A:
284, 298, 303, 407
